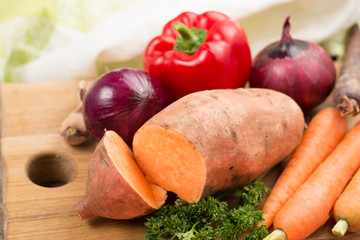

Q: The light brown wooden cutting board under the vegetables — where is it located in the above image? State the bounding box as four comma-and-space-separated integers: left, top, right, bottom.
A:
0, 79, 360, 240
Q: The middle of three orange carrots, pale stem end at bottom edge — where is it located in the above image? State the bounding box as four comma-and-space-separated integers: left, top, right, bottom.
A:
265, 121, 360, 240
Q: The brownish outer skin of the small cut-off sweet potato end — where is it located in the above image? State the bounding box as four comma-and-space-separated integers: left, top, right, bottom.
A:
74, 132, 166, 219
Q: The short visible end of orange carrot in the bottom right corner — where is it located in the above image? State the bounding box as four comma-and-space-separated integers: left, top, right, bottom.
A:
332, 169, 360, 236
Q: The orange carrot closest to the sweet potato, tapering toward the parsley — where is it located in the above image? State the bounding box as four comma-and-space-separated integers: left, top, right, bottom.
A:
262, 108, 347, 227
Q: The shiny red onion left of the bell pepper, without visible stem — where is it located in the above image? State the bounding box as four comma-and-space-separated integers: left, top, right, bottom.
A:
83, 68, 169, 146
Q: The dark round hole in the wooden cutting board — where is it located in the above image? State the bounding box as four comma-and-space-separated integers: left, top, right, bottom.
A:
27, 153, 76, 188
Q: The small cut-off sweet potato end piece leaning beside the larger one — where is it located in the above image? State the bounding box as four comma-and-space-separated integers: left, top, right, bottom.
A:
75, 131, 167, 219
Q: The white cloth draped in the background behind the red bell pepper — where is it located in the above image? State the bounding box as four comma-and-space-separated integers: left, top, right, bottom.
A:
6, 0, 359, 83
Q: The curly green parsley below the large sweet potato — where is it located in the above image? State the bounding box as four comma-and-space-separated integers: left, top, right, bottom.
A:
145, 181, 270, 240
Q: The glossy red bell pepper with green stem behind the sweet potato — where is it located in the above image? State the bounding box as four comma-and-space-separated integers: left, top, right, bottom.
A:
144, 11, 251, 100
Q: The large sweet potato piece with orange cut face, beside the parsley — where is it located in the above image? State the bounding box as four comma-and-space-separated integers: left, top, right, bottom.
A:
133, 88, 305, 202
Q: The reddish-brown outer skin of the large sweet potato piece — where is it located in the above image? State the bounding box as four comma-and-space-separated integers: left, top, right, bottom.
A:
133, 88, 305, 202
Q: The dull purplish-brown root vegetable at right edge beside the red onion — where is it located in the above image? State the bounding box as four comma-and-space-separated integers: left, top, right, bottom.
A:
334, 24, 360, 116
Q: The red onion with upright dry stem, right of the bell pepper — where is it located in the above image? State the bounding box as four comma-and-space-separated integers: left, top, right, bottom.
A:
249, 16, 336, 111
